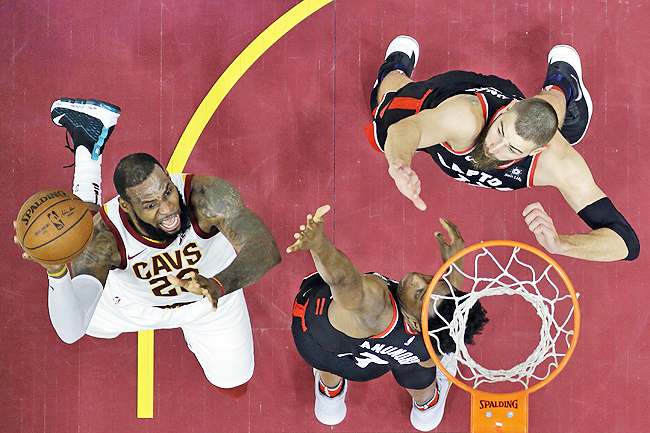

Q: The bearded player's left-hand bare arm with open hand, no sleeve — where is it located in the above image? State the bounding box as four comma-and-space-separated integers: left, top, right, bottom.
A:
384, 95, 483, 210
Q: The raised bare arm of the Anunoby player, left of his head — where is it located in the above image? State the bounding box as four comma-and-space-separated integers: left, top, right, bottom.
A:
287, 205, 392, 330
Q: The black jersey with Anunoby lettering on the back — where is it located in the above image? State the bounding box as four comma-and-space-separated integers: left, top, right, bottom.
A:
293, 273, 430, 370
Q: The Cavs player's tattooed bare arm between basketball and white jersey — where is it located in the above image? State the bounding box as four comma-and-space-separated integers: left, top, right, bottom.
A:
72, 214, 121, 285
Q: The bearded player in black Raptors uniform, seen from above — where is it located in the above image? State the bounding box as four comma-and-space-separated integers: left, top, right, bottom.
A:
366, 36, 639, 261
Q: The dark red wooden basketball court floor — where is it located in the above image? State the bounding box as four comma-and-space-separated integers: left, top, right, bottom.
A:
0, 0, 650, 433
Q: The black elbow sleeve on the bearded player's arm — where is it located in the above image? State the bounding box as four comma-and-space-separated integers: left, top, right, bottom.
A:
578, 197, 640, 260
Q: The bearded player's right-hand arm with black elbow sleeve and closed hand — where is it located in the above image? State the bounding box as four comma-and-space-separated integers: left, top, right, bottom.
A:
523, 141, 638, 261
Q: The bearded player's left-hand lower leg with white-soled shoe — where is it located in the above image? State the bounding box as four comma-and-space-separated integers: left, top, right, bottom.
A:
370, 35, 420, 110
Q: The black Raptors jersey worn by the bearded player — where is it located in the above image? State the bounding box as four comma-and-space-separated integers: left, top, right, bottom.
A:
366, 71, 540, 191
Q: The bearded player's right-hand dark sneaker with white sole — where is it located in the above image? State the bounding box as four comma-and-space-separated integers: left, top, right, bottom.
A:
544, 45, 593, 146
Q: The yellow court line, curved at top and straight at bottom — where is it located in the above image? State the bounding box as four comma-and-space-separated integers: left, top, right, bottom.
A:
137, 0, 333, 418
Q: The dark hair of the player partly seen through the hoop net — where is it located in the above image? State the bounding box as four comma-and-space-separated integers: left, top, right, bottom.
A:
428, 289, 490, 354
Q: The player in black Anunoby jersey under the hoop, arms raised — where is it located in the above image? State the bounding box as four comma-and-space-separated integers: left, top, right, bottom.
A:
287, 206, 487, 431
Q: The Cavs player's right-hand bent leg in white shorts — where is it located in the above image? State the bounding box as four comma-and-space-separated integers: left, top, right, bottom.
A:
181, 290, 255, 397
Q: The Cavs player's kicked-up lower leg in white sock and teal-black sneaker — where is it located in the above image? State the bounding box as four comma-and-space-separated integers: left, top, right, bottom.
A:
51, 98, 120, 211
